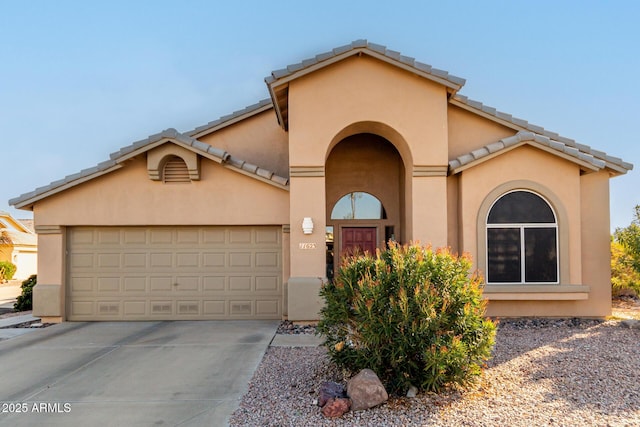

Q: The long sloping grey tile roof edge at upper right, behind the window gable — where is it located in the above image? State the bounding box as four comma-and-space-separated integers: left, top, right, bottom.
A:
449, 94, 633, 173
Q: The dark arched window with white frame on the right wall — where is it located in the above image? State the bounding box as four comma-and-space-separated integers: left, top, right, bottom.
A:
487, 190, 559, 284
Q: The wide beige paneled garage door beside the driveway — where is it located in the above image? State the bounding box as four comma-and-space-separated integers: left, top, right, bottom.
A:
67, 227, 282, 320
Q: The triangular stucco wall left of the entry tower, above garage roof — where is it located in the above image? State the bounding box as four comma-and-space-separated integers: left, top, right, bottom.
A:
199, 109, 289, 176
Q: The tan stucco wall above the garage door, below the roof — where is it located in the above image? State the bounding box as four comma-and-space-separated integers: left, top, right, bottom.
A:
34, 156, 289, 226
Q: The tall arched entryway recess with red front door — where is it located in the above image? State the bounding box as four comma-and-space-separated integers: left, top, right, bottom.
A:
325, 133, 405, 278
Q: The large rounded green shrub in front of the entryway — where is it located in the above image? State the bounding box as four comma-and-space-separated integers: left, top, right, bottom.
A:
318, 242, 495, 394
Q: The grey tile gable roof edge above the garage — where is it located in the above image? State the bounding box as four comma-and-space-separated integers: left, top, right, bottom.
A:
9, 129, 289, 208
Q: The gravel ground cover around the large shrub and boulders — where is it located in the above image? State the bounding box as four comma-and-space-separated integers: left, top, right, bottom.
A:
230, 319, 640, 427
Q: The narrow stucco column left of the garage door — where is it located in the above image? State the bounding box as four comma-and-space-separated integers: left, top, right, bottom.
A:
33, 226, 66, 323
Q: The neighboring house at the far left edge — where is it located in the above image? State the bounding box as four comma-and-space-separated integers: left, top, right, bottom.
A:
0, 211, 38, 280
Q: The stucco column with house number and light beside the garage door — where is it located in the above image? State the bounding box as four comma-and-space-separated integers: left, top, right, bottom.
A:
287, 172, 326, 320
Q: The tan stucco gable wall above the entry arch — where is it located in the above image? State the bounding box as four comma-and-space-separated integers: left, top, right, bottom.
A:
289, 56, 448, 165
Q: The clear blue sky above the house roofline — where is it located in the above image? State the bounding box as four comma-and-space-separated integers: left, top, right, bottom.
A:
0, 0, 640, 228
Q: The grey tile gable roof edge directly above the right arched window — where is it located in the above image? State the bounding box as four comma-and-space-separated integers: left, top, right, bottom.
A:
449, 131, 633, 174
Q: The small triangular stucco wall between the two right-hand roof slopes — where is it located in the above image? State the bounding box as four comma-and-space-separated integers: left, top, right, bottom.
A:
447, 104, 516, 159
